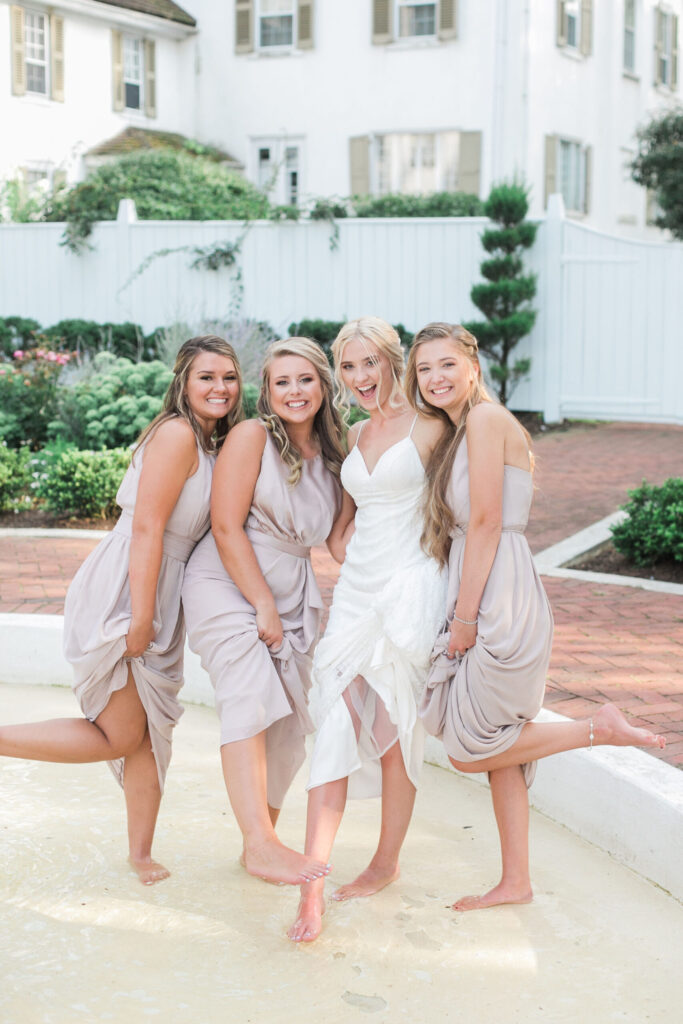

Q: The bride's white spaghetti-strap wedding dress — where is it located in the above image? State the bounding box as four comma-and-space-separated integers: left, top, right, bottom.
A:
308, 417, 446, 797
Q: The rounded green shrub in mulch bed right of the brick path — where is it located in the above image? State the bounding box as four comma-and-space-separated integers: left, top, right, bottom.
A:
611, 477, 683, 565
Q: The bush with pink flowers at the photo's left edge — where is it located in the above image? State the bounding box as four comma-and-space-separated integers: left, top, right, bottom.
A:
0, 348, 70, 449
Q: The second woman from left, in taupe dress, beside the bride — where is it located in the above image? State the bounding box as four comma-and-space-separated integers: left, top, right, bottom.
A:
182, 338, 343, 884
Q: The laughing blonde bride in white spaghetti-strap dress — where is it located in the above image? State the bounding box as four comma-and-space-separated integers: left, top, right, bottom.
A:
289, 316, 445, 942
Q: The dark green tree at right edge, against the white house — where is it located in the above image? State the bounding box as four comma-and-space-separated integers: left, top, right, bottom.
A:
631, 106, 683, 239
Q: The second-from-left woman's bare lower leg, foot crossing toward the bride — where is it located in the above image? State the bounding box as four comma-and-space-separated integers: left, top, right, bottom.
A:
220, 732, 330, 885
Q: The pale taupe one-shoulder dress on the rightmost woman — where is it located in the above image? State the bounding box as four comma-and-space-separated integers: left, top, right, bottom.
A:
420, 437, 553, 786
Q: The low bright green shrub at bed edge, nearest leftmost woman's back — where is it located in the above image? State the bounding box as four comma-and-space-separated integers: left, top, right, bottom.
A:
38, 449, 130, 519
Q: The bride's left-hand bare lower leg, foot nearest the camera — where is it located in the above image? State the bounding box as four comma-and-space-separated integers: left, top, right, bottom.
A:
287, 778, 348, 942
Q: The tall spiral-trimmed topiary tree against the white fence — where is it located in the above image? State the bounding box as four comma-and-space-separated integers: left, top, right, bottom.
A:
464, 184, 538, 406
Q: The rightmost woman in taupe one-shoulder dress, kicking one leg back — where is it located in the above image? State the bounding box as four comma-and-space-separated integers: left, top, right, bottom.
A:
405, 324, 665, 910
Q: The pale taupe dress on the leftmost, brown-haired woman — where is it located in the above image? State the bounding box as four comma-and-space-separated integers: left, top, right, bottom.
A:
63, 432, 214, 791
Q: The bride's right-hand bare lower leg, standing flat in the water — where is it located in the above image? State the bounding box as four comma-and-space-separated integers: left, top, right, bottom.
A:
332, 740, 416, 900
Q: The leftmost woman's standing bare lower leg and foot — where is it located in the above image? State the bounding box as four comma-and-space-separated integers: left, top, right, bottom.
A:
123, 732, 171, 886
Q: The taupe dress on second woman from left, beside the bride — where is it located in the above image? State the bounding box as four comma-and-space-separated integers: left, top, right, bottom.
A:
182, 428, 341, 808
